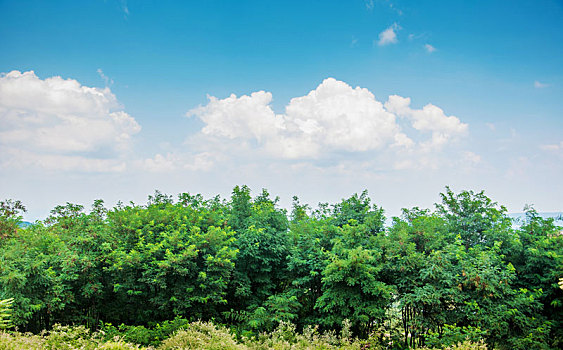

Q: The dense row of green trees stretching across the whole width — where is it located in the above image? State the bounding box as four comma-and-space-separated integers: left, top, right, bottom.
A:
0, 186, 563, 349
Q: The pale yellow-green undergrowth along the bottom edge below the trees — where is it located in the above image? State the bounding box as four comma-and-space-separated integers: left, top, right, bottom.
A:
0, 321, 487, 350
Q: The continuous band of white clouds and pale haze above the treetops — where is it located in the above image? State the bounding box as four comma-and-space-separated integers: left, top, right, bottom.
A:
0, 71, 563, 221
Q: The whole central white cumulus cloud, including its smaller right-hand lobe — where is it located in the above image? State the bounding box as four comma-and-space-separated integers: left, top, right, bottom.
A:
187, 78, 468, 159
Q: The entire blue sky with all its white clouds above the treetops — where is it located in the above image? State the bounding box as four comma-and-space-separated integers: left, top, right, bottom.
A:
0, 0, 563, 221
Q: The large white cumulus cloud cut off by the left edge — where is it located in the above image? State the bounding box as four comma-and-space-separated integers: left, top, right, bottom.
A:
0, 71, 141, 171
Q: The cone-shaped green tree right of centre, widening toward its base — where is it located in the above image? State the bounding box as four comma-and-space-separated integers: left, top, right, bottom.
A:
316, 191, 394, 336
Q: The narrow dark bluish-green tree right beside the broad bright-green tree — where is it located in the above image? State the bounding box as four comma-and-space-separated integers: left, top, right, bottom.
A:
227, 186, 288, 328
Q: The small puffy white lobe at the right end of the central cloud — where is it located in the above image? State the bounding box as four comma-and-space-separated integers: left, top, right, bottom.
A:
385, 95, 468, 150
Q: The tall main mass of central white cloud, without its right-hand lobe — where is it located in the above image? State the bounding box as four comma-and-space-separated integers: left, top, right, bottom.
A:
188, 78, 412, 159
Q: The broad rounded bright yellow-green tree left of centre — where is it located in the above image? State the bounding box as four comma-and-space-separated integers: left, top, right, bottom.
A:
106, 193, 236, 323
